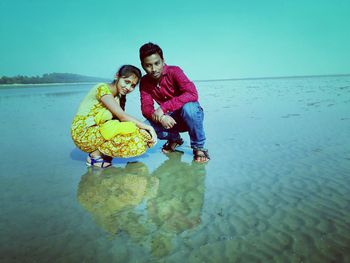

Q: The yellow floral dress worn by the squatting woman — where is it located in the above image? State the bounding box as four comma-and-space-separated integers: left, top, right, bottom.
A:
71, 83, 151, 157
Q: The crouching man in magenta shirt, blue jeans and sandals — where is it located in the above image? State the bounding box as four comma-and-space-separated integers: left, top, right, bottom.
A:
140, 43, 210, 163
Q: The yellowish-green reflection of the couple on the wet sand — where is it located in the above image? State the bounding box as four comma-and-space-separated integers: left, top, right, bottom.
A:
78, 152, 205, 257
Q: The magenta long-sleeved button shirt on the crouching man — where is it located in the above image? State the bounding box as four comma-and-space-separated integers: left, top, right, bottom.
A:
140, 65, 198, 119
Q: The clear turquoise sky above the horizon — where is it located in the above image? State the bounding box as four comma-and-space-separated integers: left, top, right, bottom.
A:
0, 0, 350, 80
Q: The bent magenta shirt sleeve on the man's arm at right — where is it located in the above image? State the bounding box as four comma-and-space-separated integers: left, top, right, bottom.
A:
160, 67, 198, 113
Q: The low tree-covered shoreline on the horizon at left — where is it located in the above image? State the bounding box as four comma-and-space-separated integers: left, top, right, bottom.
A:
0, 73, 106, 84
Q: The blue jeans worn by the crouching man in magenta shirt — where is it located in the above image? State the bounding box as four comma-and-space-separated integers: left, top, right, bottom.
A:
147, 102, 205, 149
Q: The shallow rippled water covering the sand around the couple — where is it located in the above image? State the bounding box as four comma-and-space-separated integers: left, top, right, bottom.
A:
0, 76, 350, 262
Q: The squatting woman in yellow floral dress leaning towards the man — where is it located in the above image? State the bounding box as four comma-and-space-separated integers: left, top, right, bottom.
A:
71, 65, 157, 168
